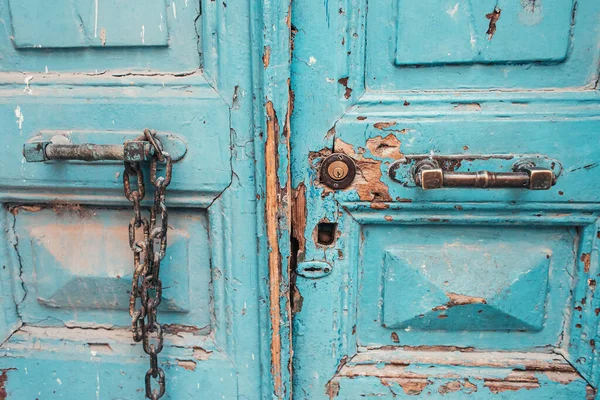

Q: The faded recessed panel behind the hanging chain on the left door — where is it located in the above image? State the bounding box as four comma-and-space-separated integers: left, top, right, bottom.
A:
9, 204, 212, 334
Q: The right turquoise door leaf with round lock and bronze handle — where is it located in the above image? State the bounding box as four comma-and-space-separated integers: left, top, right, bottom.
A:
291, 0, 600, 399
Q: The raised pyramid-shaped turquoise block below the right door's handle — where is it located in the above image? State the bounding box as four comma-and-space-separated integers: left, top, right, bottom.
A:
382, 250, 551, 331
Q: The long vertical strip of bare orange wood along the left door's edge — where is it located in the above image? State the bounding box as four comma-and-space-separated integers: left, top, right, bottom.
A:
265, 100, 283, 398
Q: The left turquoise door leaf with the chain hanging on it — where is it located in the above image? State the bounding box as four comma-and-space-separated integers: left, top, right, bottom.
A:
0, 0, 281, 399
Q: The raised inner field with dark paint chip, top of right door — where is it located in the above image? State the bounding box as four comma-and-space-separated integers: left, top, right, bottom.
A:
395, 0, 573, 67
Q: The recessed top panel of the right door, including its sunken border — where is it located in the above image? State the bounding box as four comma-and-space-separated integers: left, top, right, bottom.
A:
362, 0, 598, 91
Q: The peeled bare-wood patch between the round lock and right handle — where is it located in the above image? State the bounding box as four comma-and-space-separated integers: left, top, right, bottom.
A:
335, 138, 392, 208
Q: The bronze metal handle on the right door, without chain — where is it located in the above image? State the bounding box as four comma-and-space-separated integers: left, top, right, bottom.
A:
413, 160, 557, 190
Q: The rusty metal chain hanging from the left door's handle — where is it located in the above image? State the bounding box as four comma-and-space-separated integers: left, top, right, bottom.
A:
123, 129, 173, 400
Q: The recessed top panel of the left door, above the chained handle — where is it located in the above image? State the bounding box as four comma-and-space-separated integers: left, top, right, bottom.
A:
0, 0, 202, 71
